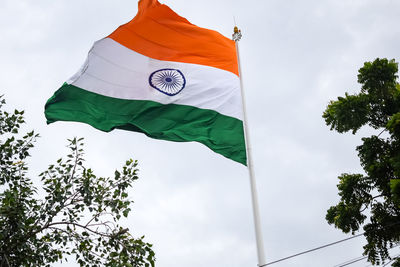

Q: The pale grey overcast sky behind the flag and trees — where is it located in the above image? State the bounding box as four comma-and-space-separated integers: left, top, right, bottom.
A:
0, 0, 400, 267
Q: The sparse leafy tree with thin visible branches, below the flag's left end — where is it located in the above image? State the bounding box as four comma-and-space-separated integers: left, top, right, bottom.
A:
0, 98, 154, 267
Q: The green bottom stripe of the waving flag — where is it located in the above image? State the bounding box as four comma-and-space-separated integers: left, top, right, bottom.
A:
45, 84, 246, 165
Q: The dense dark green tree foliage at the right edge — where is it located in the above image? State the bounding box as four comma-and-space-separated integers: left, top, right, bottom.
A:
323, 58, 400, 266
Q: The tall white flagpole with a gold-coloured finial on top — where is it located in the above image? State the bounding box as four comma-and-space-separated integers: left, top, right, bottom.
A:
232, 26, 266, 266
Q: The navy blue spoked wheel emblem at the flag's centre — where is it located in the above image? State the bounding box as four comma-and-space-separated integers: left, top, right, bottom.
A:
149, 69, 186, 96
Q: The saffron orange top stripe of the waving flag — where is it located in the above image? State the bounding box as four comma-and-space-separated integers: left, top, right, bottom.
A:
108, 1, 239, 76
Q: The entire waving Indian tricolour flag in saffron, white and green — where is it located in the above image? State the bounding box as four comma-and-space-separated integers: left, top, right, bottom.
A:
45, 0, 246, 165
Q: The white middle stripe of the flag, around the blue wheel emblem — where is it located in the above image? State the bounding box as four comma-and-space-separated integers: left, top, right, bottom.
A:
67, 38, 243, 120
